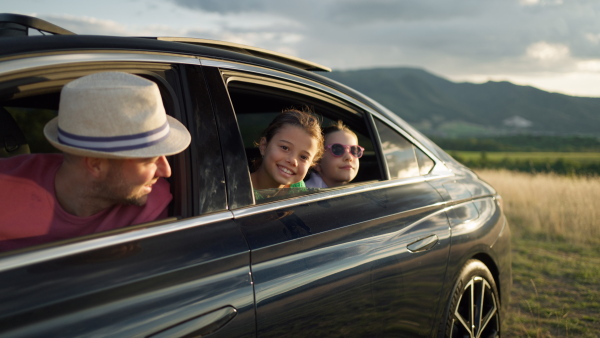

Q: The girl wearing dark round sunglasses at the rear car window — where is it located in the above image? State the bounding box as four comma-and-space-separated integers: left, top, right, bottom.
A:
306, 121, 364, 188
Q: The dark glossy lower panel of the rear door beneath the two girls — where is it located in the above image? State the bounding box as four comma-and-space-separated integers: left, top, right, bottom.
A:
236, 178, 450, 336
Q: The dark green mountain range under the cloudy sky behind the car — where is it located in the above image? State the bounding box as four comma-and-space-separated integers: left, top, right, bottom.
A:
325, 68, 600, 137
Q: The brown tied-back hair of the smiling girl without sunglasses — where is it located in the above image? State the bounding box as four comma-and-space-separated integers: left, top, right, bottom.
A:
253, 108, 324, 170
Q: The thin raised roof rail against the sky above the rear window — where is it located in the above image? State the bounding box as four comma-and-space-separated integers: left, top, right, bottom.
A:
156, 37, 331, 72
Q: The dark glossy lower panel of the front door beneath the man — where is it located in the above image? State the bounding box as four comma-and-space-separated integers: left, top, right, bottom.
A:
0, 217, 254, 337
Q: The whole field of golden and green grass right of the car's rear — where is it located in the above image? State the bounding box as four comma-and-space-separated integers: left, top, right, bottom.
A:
477, 170, 600, 337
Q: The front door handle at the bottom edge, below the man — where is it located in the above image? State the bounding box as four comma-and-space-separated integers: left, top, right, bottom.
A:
148, 306, 237, 338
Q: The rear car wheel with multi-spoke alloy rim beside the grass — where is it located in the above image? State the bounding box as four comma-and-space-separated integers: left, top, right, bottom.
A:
441, 259, 500, 338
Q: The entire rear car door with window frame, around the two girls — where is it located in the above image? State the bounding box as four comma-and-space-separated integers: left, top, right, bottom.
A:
205, 62, 449, 336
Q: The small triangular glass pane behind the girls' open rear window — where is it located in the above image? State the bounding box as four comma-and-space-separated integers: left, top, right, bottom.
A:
375, 119, 434, 179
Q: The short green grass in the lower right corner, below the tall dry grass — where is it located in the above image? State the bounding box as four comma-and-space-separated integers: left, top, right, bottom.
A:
504, 236, 600, 337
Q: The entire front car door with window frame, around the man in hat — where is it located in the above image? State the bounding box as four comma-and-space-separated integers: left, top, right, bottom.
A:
0, 53, 255, 337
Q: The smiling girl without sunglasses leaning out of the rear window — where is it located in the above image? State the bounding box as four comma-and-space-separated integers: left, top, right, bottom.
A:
250, 109, 323, 199
